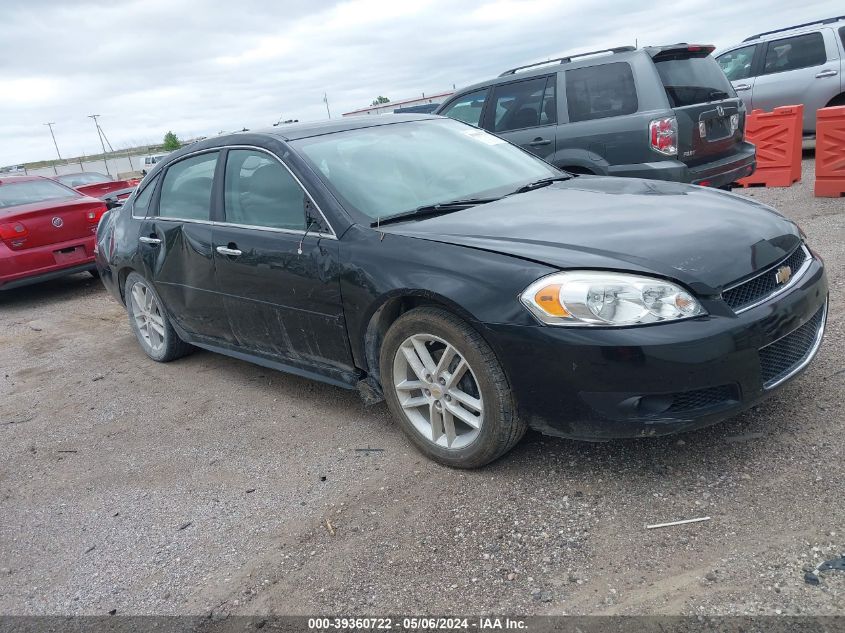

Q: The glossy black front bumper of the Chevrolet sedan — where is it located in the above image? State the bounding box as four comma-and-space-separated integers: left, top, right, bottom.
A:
483, 259, 828, 441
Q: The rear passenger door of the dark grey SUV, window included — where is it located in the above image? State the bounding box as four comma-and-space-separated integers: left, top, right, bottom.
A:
483, 74, 557, 159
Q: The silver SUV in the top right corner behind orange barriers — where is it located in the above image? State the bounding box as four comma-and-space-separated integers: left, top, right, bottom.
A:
716, 16, 845, 136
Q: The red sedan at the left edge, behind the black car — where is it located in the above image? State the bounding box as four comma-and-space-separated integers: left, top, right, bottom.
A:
0, 176, 107, 290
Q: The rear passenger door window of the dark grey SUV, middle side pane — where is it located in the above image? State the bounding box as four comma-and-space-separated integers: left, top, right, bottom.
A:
493, 77, 557, 132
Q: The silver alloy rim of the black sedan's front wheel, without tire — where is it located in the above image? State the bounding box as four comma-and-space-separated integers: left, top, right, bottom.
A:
393, 334, 484, 450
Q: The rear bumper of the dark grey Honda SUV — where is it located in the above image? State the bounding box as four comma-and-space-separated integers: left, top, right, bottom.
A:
608, 141, 757, 187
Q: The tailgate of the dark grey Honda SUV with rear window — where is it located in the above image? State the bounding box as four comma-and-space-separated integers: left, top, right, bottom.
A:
652, 46, 745, 167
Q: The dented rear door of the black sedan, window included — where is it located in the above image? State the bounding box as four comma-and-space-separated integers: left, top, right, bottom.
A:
138, 150, 224, 340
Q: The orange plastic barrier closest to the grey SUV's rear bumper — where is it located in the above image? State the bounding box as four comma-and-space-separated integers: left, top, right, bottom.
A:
737, 105, 804, 187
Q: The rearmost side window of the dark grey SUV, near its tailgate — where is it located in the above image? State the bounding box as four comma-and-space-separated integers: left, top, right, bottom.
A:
566, 62, 639, 123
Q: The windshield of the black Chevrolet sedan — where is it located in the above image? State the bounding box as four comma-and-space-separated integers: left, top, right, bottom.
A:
292, 119, 561, 219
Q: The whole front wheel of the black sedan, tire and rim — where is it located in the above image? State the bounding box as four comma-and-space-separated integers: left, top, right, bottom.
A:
380, 307, 527, 468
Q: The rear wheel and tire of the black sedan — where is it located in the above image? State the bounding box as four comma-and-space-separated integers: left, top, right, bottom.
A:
124, 273, 193, 363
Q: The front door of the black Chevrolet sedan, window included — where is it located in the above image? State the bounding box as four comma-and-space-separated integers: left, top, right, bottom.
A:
213, 149, 353, 370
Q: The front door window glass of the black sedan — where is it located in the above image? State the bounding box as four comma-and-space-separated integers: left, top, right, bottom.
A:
223, 149, 306, 231
